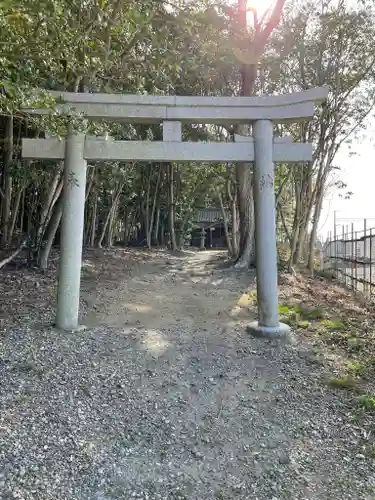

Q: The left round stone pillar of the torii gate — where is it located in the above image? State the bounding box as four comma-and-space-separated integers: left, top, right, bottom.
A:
56, 127, 87, 330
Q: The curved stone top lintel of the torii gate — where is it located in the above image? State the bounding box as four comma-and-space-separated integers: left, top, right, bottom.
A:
25, 87, 328, 124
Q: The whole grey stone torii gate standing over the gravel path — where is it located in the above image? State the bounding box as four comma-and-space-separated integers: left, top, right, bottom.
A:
22, 87, 328, 337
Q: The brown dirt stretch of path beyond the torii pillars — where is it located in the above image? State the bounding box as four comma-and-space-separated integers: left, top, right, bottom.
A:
84, 252, 253, 329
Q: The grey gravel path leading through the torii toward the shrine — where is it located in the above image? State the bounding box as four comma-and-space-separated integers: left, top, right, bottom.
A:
0, 252, 375, 500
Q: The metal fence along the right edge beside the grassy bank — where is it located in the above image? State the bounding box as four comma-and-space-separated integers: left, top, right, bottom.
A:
321, 220, 375, 300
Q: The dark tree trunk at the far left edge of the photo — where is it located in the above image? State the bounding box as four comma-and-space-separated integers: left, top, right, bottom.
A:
1, 115, 13, 245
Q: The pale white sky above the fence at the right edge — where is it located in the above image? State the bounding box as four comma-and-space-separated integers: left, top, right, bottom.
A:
318, 119, 375, 239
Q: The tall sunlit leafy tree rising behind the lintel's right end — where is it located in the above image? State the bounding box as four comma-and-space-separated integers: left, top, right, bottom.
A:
267, 0, 375, 268
